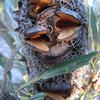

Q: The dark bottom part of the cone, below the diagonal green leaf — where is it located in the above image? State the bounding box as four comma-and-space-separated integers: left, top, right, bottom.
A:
36, 74, 72, 96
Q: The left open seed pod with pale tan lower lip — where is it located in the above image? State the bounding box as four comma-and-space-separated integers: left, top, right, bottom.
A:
25, 25, 49, 52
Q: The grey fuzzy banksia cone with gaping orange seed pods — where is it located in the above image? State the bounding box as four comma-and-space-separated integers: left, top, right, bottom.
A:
14, 0, 87, 99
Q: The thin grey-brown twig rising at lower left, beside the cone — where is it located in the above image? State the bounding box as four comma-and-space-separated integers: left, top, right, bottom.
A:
2, 45, 21, 93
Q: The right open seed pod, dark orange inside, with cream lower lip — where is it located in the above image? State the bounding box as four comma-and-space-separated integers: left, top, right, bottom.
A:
56, 7, 81, 41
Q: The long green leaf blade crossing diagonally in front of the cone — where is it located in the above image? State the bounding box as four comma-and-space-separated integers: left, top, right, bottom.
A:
40, 52, 97, 79
